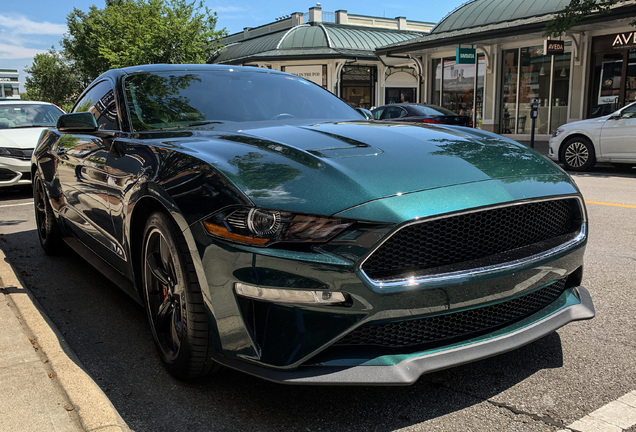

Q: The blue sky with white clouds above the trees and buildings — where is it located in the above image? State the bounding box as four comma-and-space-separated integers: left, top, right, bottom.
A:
0, 0, 466, 91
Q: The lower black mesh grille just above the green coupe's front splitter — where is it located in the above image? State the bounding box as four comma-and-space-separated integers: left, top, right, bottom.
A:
336, 278, 566, 348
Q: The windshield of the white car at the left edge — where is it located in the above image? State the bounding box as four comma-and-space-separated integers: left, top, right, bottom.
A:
0, 103, 64, 129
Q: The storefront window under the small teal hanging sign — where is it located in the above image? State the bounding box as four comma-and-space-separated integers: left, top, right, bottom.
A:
432, 55, 485, 127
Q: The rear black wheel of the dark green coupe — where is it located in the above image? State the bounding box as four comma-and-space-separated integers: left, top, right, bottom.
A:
33, 173, 64, 255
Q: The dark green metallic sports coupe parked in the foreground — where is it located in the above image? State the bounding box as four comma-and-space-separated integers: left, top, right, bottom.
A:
32, 65, 594, 384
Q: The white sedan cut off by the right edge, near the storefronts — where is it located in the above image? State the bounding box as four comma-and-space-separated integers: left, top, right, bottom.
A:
548, 102, 636, 171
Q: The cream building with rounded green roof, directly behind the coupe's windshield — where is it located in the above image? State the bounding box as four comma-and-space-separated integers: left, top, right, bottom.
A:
214, 6, 433, 108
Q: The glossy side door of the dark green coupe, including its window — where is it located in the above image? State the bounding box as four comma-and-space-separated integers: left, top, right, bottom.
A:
53, 80, 123, 261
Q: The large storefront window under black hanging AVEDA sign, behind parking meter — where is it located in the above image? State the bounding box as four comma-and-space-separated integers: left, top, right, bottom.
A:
500, 43, 571, 134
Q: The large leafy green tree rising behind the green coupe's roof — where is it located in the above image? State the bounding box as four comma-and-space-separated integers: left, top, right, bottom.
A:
62, 0, 226, 81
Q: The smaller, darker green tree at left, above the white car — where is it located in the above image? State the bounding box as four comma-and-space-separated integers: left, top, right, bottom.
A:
24, 48, 85, 110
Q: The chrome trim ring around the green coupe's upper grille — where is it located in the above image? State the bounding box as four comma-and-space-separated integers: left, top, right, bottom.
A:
358, 195, 587, 289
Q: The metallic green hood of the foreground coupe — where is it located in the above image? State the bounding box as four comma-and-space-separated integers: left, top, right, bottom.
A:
166, 122, 573, 219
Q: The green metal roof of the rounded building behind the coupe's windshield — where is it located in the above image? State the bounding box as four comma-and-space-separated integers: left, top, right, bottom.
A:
214, 23, 423, 63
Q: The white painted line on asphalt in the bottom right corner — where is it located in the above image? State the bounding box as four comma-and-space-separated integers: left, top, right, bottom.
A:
559, 390, 636, 432
